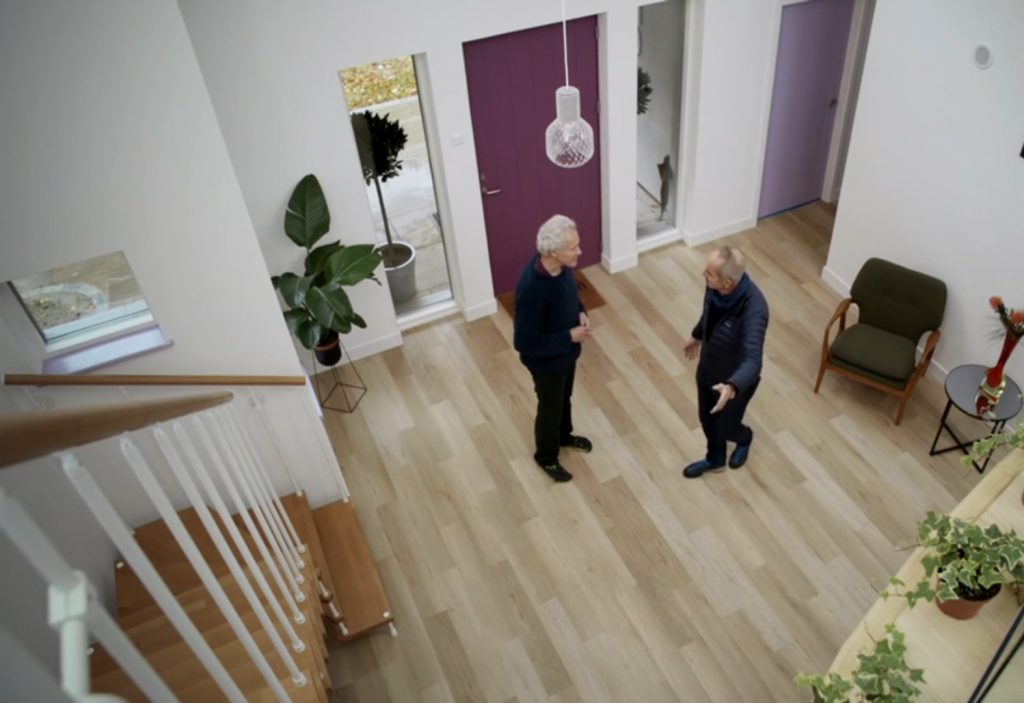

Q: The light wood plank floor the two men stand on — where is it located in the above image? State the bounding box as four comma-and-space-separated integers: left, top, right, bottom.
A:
317, 204, 980, 703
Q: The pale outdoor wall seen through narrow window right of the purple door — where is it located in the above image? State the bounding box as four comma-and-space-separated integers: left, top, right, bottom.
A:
637, 0, 684, 211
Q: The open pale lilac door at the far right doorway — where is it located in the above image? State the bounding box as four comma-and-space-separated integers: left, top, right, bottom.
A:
758, 0, 853, 217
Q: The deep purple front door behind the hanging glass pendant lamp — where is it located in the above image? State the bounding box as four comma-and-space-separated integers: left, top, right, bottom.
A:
463, 17, 601, 296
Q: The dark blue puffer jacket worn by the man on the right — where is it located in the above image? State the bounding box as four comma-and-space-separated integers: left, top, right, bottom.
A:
691, 280, 768, 393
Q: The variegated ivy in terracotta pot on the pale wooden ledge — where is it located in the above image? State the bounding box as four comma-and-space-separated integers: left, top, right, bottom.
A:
882, 511, 1024, 620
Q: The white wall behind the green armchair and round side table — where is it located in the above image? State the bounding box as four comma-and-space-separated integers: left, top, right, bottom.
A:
823, 0, 1024, 383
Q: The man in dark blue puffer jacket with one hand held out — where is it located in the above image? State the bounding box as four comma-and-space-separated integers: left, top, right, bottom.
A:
683, 247, 768, 479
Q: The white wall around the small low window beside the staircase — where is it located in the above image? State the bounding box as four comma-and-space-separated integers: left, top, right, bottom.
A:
0, 0, 335, 675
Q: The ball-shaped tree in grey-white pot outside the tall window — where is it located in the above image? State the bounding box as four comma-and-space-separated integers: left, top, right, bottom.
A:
352, 109, 416, 304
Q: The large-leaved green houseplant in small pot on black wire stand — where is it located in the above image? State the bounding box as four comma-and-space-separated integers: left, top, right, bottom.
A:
270, 174, 381, 366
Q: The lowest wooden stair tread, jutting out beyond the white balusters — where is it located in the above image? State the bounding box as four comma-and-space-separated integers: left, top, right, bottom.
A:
312, 500, 394, 640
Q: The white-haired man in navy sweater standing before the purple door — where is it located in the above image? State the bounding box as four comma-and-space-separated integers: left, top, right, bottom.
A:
513, 215, 594, 482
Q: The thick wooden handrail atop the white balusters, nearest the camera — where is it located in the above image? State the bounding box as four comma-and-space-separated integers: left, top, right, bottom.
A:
0, 391, 234, 468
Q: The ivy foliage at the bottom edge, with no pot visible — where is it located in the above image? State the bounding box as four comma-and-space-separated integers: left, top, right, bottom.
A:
795, 623, 925, 703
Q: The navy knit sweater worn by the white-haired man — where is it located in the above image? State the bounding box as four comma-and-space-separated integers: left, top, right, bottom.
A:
513, 254, 583, 374
